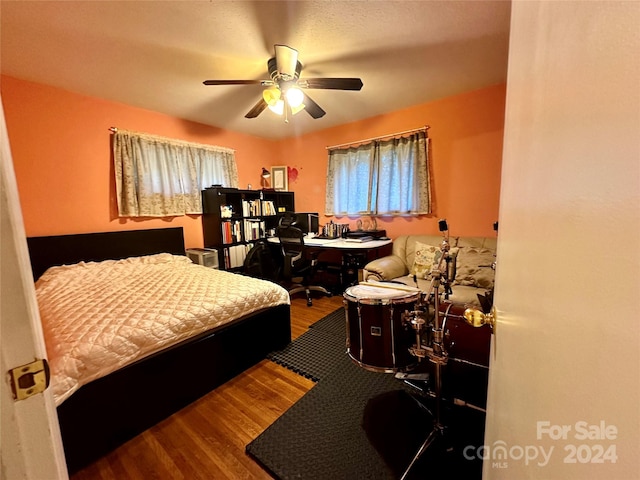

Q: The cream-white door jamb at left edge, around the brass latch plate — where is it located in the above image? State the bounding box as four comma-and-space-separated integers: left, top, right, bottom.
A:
0, 99, 68, 480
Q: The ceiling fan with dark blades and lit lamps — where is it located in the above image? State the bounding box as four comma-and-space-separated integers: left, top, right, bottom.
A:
203, 45, 362, 123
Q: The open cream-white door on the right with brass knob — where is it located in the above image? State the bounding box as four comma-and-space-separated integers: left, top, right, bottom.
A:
482, 1, 640, 480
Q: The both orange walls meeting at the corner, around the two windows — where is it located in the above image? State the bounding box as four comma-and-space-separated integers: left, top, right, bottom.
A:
1, 76, 506, 247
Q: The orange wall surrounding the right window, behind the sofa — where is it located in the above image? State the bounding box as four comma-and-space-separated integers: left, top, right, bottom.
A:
280, 84, 506, 238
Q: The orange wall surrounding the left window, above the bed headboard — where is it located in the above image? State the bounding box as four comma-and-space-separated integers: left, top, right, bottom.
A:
1, 76, 274, 247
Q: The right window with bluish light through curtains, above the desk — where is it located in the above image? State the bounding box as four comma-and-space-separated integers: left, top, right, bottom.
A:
325, 132, 431, 216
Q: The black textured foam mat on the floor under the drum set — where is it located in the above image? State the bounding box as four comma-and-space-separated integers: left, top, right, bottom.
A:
246, 311, 484, 480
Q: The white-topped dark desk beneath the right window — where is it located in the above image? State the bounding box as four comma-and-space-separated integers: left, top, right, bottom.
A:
268, 237, 393, 294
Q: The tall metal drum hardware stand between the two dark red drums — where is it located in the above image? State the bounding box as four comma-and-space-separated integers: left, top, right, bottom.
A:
401, 225, 450, 480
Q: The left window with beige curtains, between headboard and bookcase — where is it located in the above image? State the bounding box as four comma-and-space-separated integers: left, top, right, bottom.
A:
113, 130, 238, 217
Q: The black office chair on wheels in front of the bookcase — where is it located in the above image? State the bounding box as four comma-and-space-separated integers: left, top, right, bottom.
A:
277, 222, 331, 307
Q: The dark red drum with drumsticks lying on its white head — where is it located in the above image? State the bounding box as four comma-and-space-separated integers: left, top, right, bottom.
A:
344, 285, 420, 373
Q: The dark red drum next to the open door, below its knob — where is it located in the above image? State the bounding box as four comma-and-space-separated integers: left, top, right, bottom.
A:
439, 302, 491, 368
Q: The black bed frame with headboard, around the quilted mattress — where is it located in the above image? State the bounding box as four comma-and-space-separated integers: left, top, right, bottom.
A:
27, 228, 291, 473
